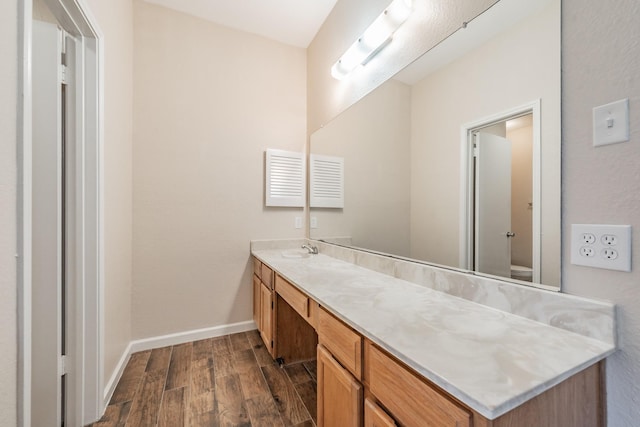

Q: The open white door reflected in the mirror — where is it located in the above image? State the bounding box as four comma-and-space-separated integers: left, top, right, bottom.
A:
474, 132, 512, 277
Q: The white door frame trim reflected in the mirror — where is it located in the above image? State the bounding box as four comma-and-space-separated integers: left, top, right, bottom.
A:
459, 99, 542, 286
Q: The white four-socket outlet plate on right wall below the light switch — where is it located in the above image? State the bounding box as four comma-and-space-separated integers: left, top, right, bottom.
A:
571, 224, 631, 271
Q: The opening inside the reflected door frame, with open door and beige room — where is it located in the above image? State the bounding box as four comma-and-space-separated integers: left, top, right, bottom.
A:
473, 113, 533, 282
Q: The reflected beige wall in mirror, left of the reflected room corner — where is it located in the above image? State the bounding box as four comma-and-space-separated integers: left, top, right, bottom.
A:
311, 80, 411, 257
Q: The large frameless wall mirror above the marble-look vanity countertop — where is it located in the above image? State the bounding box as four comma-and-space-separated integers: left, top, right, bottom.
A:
309, 0, 561, 289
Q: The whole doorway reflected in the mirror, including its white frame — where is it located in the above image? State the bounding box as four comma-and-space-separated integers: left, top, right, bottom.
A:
461, 102, 540, 283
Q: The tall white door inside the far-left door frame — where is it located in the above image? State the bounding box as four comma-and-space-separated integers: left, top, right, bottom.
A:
31, 21, 74, 426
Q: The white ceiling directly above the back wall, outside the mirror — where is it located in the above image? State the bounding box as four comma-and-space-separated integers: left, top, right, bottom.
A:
145, 0, 337, 48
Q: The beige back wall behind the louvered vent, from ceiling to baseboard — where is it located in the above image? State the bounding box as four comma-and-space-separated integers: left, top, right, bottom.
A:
133, 1, 306, 338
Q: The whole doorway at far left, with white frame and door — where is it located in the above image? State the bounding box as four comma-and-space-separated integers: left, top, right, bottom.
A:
18, 0, 104, 426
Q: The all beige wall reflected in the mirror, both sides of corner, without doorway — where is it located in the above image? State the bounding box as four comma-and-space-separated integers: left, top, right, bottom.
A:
310, 1, 560, 287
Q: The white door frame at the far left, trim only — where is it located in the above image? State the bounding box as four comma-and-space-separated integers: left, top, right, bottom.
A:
17, 0, 105, 427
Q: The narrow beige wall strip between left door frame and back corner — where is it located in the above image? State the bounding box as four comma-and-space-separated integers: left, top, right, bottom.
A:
87, 0, 133, 381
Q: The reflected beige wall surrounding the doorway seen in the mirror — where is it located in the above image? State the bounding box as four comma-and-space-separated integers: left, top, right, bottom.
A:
411, 2, 560, 285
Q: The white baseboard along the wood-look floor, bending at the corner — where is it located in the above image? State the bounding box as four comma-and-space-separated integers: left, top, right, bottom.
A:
104, 320, 256, 408
